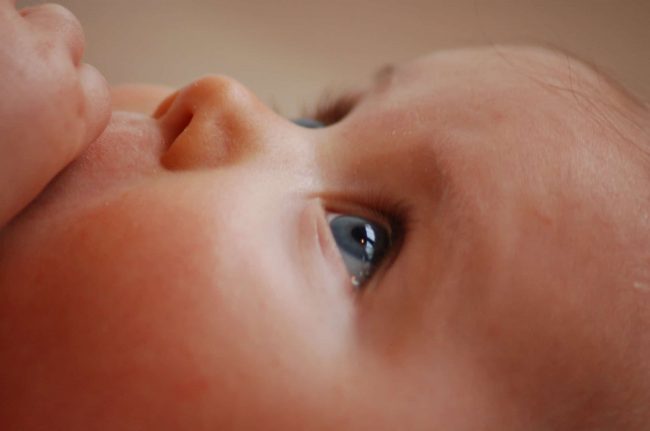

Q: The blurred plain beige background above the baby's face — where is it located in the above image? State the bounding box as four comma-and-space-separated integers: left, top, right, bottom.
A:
19, 0, 650, 115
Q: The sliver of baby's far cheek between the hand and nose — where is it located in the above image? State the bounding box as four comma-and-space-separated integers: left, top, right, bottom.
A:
111, 84, 176, 115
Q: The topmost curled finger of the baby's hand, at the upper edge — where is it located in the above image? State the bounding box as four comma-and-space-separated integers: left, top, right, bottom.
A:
20, 3, 86, 66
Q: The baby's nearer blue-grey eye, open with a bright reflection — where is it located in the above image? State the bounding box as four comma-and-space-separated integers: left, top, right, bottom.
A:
328, 214, 392, 288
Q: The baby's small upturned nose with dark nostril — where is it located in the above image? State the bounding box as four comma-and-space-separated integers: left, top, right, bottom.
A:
154, 76, 273, 170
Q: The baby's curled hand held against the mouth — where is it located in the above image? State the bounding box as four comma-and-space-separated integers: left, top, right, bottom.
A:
0, 0, 110, 227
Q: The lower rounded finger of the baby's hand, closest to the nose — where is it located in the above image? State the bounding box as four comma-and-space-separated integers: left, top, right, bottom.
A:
79, 64, 111, 147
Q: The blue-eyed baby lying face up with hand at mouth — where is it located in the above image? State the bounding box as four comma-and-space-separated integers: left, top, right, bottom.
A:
0, 0, 650, 431
